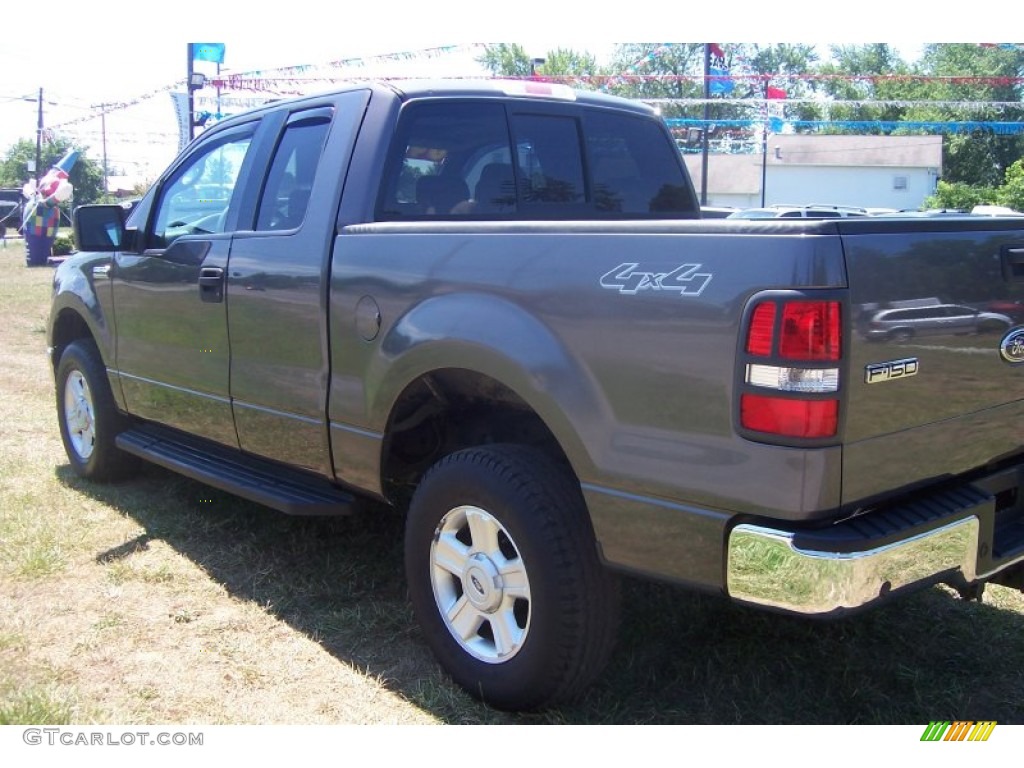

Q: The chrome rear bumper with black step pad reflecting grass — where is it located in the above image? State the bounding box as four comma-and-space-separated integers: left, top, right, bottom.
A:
726, 462, 1024, 614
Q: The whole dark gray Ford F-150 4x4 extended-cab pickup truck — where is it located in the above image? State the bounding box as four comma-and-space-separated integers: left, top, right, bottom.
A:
48, 81, 1024, 709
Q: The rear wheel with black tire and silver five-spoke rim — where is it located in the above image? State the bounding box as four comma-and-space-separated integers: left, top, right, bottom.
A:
406, 445, 620, 711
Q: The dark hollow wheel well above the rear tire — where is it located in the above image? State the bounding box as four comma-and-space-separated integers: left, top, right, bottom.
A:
381, 369, 571, 508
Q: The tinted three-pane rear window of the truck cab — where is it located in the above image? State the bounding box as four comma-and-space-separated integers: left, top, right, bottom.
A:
376, 101, 697, 221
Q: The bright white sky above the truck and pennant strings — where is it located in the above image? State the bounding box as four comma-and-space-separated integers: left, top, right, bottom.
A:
0, 0, 1012, 185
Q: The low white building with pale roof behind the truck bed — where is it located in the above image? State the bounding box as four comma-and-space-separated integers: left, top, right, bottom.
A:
684, 134, 942, 210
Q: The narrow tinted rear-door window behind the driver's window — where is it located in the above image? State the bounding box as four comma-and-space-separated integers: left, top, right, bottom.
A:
256, 110, 331, 230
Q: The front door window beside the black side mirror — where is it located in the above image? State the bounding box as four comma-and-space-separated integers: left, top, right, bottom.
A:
146, 131, 252, 249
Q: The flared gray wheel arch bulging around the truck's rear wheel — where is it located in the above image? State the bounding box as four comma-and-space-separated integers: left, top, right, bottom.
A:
366, 293, 611, 477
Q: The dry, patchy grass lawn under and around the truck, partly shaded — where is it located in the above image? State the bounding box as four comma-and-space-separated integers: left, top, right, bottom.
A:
0, 242, 1024, 728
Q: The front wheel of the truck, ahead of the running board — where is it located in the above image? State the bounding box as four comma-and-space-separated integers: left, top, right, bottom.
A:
55, 339, 138, 480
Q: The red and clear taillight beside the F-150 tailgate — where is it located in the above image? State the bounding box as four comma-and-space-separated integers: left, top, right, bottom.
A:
739, 297, 843, 439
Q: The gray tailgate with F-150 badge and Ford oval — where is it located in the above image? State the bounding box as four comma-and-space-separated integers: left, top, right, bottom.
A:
840, 216, 1024, 505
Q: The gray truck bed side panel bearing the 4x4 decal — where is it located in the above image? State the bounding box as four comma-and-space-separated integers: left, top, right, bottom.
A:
330, 222, 845, 519
